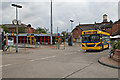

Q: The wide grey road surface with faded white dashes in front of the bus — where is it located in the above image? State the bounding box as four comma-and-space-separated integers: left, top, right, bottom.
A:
1, 46, 118, 78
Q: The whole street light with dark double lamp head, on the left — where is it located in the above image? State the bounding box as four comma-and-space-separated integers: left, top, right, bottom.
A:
11, 4, 22, 52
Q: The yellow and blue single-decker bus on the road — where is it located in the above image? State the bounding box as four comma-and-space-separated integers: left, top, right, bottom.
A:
82, 30, 110, 51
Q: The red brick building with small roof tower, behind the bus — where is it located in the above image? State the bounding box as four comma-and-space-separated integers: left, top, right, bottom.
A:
72, 14, 120, 40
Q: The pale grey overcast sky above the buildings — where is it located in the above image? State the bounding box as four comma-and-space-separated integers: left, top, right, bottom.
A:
0, 0, 119, 32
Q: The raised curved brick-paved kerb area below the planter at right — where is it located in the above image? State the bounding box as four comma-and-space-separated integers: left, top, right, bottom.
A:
98, 56, 120, 69
